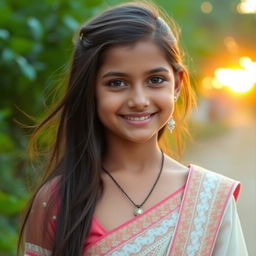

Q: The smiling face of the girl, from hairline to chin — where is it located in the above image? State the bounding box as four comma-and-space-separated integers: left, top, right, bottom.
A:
96, 40, 180, 143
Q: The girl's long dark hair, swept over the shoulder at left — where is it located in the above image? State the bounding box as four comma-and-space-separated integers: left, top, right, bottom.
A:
19, 3, 194, 256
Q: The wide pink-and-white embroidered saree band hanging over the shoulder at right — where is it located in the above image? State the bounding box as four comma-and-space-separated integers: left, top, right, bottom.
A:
169, 166, 238, 256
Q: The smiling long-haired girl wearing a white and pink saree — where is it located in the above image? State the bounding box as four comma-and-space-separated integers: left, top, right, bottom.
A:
19, 3, 247, 256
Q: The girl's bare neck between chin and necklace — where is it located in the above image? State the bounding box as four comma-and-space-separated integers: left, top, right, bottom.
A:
103, 137, 161, 173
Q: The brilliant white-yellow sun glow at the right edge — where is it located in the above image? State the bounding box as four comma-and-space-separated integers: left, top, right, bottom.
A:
203, 57, 256, 93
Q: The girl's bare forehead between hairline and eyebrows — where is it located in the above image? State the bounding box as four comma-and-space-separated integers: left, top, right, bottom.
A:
99, 40, 172, 75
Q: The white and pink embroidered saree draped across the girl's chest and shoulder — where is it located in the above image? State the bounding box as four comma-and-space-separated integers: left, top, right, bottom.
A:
25, 165, 248, 256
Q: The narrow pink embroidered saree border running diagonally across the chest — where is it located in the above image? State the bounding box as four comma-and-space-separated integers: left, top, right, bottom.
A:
85, 189, 183, 256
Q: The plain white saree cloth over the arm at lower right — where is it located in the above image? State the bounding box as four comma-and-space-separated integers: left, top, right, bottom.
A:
212, 196, 248, 256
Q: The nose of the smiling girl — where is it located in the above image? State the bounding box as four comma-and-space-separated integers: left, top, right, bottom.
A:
128, 87, 150, 111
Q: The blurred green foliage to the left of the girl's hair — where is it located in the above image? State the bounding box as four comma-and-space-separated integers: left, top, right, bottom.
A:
0, 0, 102, 256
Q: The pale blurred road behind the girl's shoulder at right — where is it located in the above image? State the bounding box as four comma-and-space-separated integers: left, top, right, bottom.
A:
184, 105, 256, 255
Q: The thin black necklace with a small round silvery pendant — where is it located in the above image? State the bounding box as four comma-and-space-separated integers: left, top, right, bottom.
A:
102, 150, 164, 216
